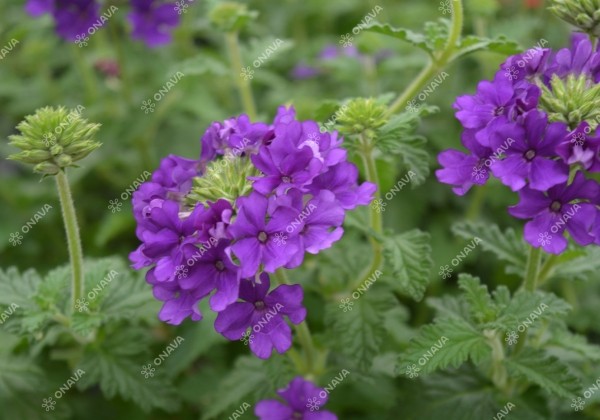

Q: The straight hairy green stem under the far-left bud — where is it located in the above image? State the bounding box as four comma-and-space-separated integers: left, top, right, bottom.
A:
56, 171, 84, 311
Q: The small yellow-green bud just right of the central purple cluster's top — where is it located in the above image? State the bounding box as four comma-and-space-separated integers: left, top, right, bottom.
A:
337, 98, 387, 134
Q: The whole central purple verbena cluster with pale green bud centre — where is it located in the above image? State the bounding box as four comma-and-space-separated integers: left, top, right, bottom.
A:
130, 107, 376, 358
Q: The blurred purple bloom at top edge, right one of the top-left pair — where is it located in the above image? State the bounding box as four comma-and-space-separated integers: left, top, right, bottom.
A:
128, 0, 179, 47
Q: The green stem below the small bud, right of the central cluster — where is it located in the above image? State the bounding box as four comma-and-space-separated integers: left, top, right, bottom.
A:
352, 134, 383, 290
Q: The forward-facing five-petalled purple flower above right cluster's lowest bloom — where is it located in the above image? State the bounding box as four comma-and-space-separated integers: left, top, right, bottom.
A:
490, 111, 569, 191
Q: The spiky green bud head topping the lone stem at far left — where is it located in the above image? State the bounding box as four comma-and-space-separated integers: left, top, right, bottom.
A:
9, 107, 101, 175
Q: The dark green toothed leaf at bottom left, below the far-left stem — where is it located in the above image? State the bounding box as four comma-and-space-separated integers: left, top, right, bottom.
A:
78, 327, 179, 412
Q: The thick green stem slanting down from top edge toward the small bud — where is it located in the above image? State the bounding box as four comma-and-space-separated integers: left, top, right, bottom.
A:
386, 0, 463, 117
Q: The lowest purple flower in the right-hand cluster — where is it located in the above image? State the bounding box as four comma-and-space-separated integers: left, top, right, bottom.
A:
509, 172, 600, 254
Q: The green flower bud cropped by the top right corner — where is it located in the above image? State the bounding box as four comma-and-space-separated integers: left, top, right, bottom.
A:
549, 0, 600, 37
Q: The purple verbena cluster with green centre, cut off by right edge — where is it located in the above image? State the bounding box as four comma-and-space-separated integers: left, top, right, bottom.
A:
437, 34, 600, 254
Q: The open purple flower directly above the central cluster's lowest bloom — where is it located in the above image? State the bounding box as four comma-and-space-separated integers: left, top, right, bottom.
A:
229, 192, 298, 277
